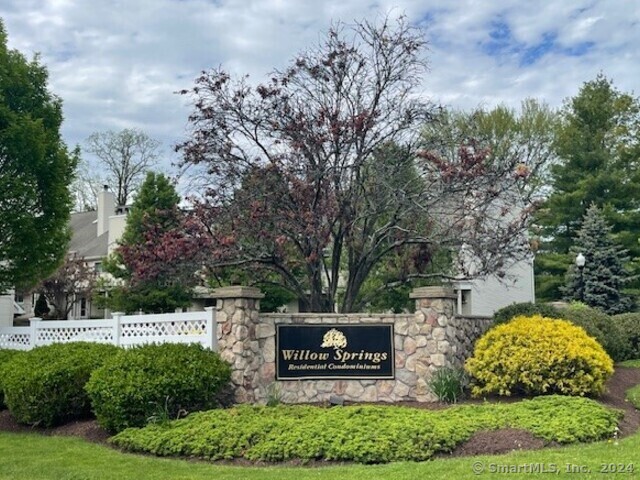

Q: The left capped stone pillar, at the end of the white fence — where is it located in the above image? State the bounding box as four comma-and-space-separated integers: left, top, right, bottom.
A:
213, 286, 264, 403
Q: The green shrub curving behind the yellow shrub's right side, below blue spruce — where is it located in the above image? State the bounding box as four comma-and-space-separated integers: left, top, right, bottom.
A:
561, 303, 631, 362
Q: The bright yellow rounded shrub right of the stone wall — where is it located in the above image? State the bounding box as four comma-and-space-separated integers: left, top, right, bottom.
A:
465, 315, 613, 396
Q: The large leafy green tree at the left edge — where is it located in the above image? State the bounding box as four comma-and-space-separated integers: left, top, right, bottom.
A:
0, 22, 76, 292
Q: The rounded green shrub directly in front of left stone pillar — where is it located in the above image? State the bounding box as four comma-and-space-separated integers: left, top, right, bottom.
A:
87, 343, 231, 432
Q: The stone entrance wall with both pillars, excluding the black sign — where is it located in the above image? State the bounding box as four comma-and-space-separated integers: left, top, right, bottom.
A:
214, 287, 490, 403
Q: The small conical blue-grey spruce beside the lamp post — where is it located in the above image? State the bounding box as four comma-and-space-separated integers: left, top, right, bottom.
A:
562, 204, 633, 315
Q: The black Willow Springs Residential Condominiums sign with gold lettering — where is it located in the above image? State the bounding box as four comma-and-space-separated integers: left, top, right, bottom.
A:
276, 324, 395, 380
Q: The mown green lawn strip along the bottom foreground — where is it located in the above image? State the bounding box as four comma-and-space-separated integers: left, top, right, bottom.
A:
0, 433, 640, 480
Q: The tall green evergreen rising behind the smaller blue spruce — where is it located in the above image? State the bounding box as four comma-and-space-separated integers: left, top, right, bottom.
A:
536, 75, 640, 300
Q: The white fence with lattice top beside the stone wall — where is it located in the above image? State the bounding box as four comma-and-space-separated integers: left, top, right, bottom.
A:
0, 307, 218, 351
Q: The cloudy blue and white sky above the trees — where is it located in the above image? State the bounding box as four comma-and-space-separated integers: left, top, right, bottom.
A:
0, 0, 640, 174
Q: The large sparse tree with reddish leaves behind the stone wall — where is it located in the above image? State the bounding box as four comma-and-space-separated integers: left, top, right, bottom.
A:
179, 18, 530, 311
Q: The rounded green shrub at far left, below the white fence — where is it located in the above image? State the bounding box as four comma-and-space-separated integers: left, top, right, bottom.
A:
3, 342, 118, 426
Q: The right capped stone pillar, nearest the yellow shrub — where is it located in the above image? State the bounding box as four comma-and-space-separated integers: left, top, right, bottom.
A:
410, 287, 459, 374
